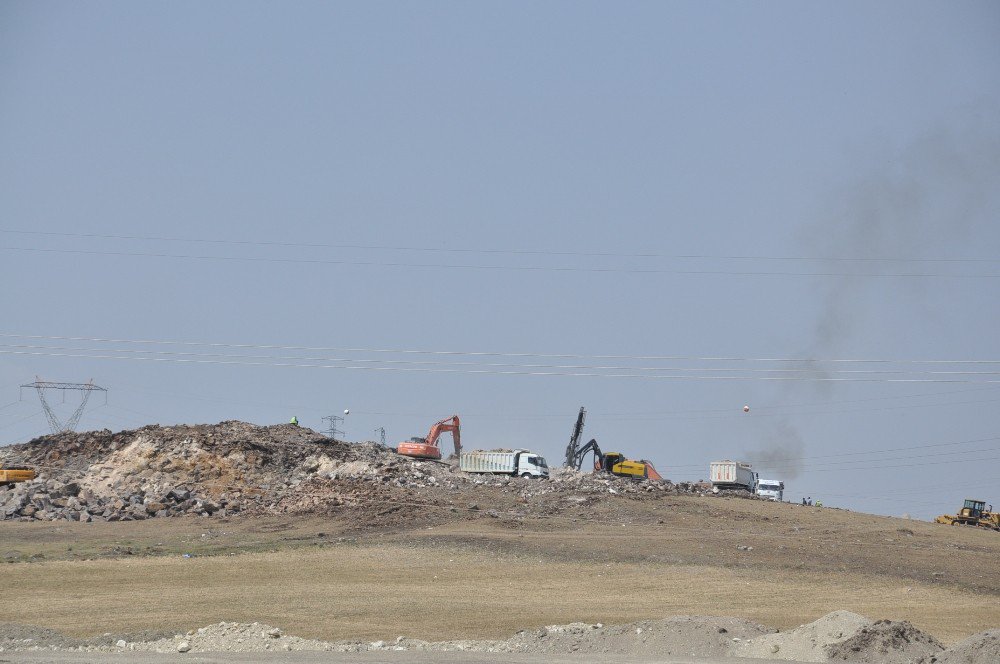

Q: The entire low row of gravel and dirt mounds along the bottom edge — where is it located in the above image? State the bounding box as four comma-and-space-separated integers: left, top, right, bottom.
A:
0, 611, 976, 664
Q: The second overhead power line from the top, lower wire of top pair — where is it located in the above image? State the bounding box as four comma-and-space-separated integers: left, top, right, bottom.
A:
0, 246, 1000, 279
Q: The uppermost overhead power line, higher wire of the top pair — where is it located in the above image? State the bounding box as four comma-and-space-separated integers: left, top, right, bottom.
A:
0, 228, 1000, 263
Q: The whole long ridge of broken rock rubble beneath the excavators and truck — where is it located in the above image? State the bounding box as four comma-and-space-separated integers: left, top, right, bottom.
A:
0, 421, 704, 522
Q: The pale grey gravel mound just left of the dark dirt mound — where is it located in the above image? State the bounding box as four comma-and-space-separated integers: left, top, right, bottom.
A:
730, 611, 873, 662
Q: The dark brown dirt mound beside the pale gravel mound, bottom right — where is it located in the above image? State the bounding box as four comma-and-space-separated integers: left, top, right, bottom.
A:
826, 620, 944, 664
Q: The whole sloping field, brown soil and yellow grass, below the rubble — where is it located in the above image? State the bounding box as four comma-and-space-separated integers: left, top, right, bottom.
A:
0, 496, 1000, 643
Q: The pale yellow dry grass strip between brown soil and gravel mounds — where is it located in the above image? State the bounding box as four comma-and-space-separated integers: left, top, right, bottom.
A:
0, 544, 998, 641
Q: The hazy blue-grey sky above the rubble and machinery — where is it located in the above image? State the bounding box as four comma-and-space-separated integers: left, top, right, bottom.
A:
0, 1, 1000, 517
